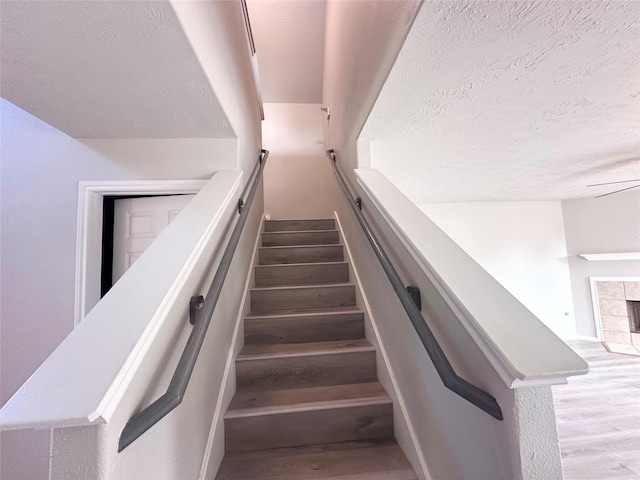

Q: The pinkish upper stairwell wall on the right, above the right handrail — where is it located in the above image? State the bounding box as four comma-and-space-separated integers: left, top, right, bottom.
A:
322, 0, 421, 181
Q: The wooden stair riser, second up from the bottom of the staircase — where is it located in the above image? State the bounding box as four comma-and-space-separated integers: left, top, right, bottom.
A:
236, 351, 377, 391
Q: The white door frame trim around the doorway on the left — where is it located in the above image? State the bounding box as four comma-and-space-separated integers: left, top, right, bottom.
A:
73, 180, 209, 328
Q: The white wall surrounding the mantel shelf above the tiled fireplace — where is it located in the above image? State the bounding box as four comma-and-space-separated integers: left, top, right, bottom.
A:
562, 190, 640, 337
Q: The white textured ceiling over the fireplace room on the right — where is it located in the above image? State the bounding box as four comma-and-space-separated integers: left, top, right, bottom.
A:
361, 0, 640, 202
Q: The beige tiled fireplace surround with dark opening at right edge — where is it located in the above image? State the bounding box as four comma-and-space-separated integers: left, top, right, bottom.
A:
594, 280, 640, 355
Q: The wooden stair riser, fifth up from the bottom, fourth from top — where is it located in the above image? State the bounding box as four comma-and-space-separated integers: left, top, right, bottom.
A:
255, 262, 349, 287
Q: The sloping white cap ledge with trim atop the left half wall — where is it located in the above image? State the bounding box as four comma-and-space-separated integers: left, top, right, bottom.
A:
0, 171, 242, 430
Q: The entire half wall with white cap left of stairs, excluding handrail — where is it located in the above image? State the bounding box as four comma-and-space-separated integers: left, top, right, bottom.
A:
0, 157, 263, 480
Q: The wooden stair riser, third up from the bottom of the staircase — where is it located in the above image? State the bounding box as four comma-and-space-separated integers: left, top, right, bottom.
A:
244, 313, 364, 344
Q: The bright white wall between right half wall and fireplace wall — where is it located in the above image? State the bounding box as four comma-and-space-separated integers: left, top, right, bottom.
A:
418, 202, 576, 338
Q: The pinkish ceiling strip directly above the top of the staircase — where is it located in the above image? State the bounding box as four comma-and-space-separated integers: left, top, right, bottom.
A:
247, 0, 326, 103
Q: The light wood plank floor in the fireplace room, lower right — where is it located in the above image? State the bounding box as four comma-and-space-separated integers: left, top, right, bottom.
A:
553, 340, 640, 480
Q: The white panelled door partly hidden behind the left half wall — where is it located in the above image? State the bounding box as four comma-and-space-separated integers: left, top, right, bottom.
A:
113, 195, 195, 284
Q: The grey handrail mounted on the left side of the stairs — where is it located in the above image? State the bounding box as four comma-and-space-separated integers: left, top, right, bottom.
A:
118, 150, 269, 452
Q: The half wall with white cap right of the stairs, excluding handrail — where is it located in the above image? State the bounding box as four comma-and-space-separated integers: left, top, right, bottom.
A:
326, 156, 588, 480
